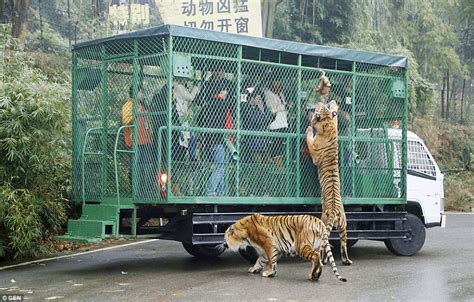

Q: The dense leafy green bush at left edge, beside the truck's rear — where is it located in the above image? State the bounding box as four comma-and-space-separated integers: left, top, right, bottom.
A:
0, 32, 70, 258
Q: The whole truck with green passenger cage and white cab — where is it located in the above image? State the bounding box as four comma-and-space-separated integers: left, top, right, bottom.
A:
58, 25, 446, 260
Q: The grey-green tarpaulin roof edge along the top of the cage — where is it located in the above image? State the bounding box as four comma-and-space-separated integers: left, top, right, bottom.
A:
73, 24, 408, 68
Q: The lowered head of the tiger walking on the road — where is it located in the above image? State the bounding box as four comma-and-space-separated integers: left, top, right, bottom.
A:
225, 214, 261, 251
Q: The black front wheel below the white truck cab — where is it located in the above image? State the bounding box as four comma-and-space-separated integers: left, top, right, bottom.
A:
384, 214, 426, 256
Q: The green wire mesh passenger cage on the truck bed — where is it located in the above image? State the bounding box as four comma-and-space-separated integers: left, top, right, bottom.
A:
72, 30, 406, 203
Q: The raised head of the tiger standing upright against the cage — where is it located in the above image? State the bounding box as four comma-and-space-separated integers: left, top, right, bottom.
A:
311, 100, 339, 140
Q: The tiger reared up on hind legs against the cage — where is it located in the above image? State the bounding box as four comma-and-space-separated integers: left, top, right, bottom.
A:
306, 100, 352, 265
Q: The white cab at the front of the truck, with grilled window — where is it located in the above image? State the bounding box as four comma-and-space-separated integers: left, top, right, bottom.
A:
407, 131, 446, 227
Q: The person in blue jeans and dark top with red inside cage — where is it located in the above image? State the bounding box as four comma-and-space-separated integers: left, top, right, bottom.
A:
198, 77, 235, 196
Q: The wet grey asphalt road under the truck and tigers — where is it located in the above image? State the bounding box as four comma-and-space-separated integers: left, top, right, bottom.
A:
0, 214, 474, 301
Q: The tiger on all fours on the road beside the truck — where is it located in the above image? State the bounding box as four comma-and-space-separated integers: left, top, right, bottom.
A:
224, 214, 346, 282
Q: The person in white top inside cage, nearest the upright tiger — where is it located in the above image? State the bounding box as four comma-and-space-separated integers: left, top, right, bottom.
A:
264, 80, 288, 162
